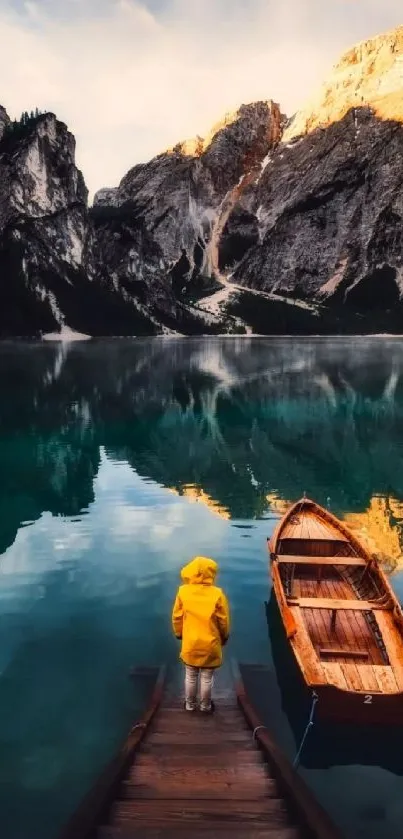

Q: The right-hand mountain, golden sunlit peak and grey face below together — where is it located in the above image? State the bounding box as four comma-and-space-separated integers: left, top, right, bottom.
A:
231, 27, 403, 322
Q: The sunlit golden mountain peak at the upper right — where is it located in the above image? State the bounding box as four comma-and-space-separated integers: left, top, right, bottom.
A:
283, 26, 403, 142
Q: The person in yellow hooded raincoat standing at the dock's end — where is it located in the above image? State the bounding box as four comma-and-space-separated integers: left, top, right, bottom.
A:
172, 556, 230, 713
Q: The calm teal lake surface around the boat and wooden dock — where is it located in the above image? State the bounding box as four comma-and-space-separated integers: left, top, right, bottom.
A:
0, 338, 403, 839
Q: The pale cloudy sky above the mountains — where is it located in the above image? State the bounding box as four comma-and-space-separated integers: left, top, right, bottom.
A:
0, 0, 403, 200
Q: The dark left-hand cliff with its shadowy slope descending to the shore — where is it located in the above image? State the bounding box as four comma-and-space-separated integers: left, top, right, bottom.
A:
0, 109, 172, 337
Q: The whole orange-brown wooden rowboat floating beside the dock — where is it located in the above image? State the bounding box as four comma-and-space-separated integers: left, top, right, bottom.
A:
268, 498, 403, 725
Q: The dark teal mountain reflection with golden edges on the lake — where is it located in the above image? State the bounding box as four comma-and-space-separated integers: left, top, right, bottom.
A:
0, 338, 403, 562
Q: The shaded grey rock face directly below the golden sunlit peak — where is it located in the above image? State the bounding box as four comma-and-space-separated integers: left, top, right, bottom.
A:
234, 109, 403, 311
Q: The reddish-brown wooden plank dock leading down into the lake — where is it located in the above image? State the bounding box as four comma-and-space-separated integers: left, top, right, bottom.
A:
60, 671, 341, 839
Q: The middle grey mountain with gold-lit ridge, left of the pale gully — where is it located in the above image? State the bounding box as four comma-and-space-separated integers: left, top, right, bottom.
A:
93, 101, 283, 293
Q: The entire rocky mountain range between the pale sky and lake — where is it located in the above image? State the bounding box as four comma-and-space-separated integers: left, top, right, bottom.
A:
0, 21, 403, 337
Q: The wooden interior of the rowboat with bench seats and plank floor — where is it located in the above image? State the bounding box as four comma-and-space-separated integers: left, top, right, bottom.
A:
277, 512, 400, 691
